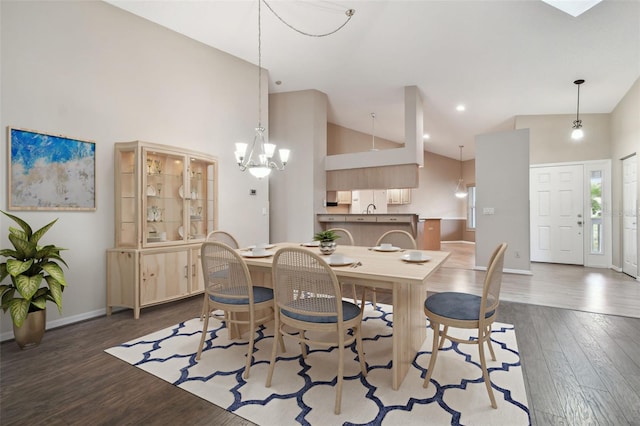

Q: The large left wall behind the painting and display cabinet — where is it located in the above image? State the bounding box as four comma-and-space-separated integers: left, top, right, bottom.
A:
0, 1, 270, 337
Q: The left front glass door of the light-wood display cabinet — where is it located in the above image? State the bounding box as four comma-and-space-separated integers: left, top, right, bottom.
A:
142, 149, 185, 246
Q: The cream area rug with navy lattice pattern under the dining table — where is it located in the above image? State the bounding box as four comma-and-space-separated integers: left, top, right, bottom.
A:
106, 304, 530, 426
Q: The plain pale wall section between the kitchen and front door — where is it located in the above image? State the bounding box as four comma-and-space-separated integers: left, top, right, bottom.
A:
476, 129, 531, 272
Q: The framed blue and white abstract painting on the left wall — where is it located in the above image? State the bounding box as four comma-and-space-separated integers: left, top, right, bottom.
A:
7, 127, 96, 210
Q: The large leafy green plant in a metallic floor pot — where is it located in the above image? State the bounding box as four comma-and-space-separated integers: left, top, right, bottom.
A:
0, 211, 68, 348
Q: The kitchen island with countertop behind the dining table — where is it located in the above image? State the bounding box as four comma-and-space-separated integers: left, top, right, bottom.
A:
317, 213, 420, 248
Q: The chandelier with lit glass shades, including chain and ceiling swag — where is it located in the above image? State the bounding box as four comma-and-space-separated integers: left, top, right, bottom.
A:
234, 0, 355, 179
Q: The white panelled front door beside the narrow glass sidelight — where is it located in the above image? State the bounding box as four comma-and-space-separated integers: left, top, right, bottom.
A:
530, 164, 584, 265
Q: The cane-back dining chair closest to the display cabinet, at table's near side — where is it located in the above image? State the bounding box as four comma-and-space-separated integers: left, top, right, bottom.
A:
196, 241, 274, 379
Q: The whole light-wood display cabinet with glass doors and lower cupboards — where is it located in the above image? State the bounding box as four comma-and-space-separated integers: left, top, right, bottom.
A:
107, 141, 217, 318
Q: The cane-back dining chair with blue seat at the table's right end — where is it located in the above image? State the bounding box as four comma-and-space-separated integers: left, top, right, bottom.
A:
423, 243, 507, 408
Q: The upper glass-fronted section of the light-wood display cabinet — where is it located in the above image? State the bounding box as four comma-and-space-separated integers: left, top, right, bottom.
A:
114, 141, 217, 249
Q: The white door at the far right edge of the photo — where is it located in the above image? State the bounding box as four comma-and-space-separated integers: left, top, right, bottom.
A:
622, 155, 638, 278
